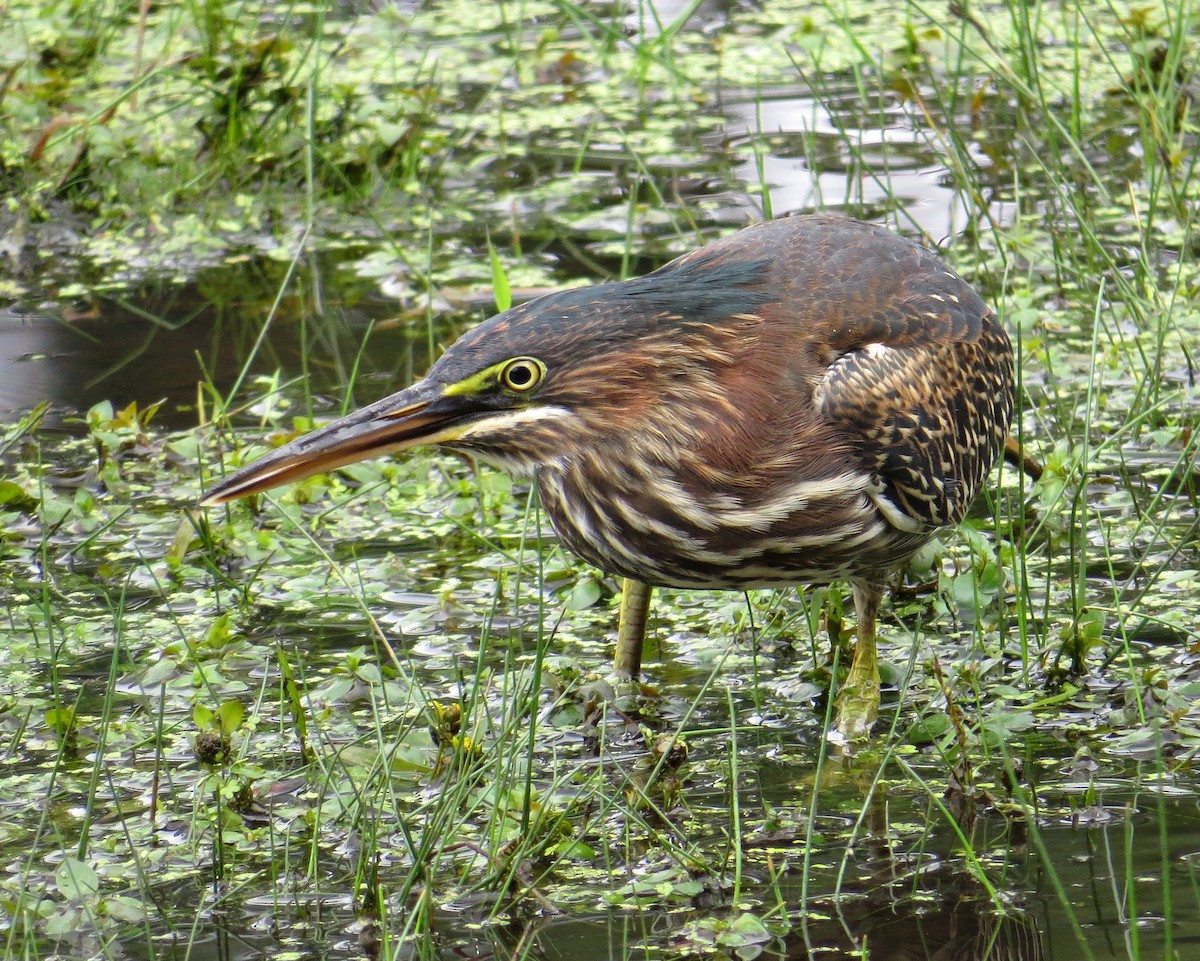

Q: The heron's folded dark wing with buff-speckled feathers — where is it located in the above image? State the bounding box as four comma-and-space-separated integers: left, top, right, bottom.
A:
814, 233, 1013, 531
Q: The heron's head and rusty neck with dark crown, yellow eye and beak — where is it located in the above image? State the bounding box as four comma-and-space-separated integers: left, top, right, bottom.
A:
202, 245, 770, 506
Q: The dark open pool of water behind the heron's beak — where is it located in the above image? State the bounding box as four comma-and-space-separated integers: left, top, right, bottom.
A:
0, 265, 441, 427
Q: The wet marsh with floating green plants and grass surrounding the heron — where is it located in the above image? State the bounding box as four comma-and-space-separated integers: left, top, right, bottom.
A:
0, 0, 1200, 961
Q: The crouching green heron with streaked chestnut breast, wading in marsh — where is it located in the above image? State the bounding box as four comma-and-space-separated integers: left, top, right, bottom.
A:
203, 216, 1013, 739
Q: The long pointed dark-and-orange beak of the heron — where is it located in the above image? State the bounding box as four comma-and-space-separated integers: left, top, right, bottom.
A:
200, 380, 465, 507
